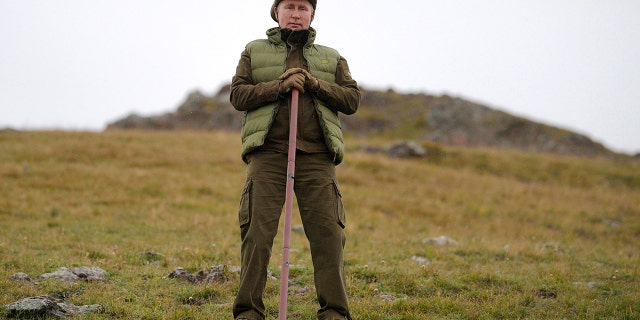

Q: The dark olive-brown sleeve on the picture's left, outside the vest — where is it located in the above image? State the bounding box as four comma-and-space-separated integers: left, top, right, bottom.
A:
230, 49, 280, 111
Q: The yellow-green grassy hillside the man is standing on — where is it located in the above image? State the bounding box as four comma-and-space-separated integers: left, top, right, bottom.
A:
0, 131, 640, 320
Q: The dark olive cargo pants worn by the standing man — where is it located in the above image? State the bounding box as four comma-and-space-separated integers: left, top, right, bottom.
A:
233, 151, 350, 320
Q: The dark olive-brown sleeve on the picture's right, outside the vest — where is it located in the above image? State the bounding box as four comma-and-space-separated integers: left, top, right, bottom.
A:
315, 56, 361, 115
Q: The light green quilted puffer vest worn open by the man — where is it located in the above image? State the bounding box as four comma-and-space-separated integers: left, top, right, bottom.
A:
241, 27, 344, 165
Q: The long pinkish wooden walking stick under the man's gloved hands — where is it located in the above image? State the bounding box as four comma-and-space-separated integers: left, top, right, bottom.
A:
278, 89, 299, 320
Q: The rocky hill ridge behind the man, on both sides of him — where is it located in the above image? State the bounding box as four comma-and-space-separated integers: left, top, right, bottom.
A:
107, 85, 614, 156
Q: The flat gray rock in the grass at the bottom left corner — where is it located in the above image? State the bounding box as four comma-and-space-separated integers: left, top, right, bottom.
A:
3, 296, 104, 319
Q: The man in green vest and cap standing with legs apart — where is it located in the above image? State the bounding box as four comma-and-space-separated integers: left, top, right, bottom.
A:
231, 0, 360, 320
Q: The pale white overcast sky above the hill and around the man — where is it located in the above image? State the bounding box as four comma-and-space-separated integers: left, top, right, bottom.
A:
0, 0, 640, 153
